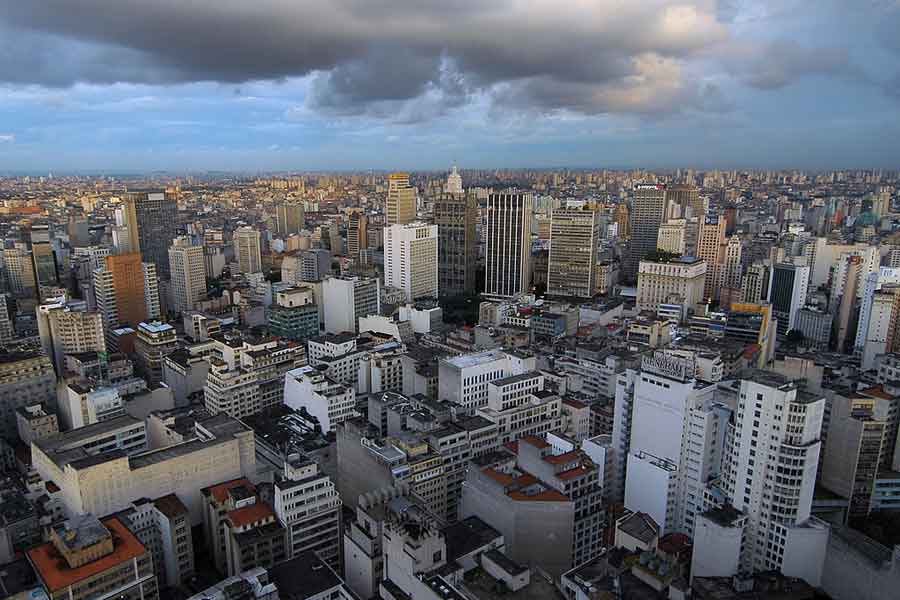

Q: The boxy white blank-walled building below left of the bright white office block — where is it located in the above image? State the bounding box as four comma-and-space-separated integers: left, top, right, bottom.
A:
322, 277, 381, 333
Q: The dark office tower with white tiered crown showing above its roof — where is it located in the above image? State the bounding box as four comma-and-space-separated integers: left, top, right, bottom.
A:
434, 183, 478, 296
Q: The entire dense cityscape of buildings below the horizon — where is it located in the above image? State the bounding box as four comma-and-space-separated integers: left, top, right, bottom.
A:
0, 167, 900, 600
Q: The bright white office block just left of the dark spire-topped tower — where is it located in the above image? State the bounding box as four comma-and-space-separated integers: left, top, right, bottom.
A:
384, 222, 438, 302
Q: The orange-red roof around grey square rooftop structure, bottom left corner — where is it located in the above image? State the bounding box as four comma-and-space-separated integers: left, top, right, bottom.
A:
28, 517, 146, 594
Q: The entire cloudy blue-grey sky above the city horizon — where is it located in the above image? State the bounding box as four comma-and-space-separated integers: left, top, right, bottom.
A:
0, 0, 900, 172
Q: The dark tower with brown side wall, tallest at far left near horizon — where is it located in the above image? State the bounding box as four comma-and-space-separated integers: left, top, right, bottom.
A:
123, 192, 178, 277
